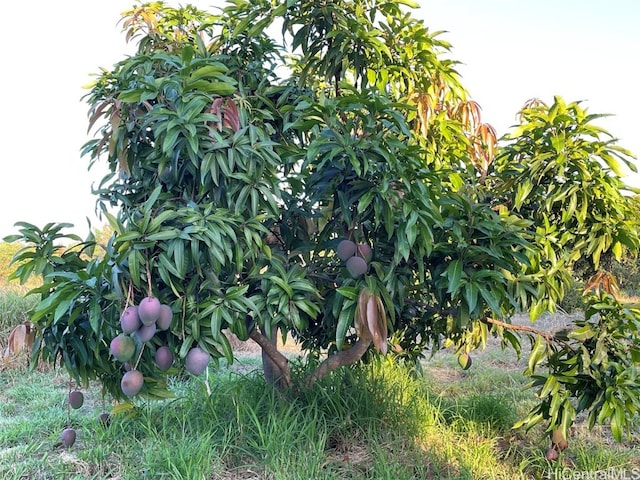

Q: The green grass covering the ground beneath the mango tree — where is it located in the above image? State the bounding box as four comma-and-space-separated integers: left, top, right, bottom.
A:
0, 349, 640, 480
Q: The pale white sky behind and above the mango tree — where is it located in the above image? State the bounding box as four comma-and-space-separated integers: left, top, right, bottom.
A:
0, 0, 640, 238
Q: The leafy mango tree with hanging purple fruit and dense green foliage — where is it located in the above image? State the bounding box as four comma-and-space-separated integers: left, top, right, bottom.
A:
10, 0, 640, 454
